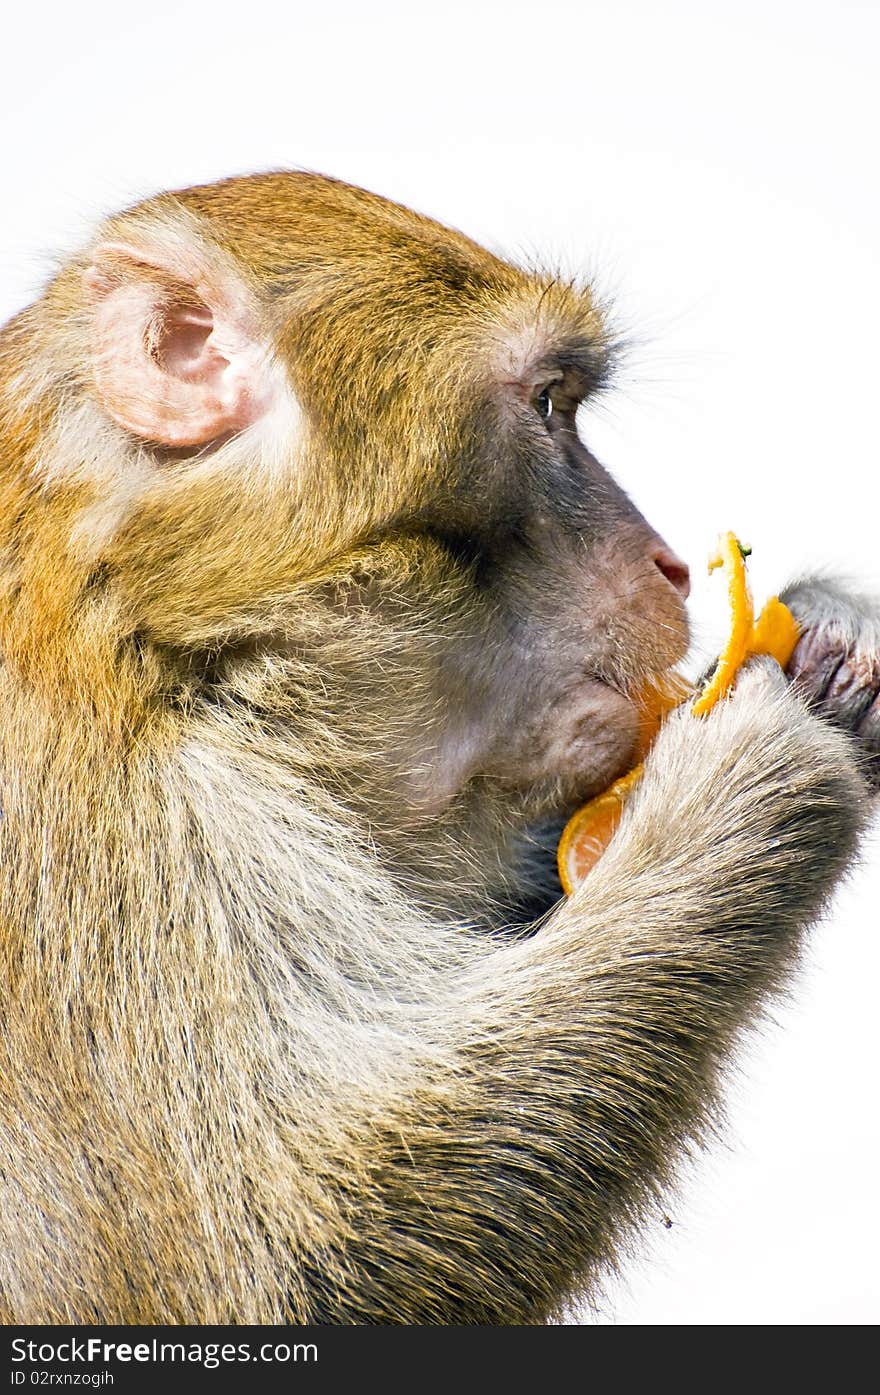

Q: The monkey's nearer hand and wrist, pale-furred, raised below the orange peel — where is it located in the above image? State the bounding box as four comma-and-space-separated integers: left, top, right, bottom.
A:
599, 650, 866, 939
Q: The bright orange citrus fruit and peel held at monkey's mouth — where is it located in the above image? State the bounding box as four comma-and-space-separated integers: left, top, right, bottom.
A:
556, 533, 801, 896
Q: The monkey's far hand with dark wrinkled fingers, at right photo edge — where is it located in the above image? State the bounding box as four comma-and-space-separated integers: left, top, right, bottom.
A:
781, 579, 880, 791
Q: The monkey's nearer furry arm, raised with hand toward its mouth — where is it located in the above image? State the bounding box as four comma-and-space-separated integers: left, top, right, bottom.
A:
312, 664, 865, 1322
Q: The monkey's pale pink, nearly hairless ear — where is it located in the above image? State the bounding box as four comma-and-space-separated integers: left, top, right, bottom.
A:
84, 241, 276, 446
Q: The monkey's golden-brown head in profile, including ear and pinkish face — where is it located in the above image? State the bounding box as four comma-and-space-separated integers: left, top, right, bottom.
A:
0, 174, 688, 822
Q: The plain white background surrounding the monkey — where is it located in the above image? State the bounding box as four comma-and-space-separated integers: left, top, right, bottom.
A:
0, 0, 880, 1324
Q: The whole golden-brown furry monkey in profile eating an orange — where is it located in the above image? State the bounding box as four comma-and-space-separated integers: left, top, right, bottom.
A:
0, 172, 880, 1325
